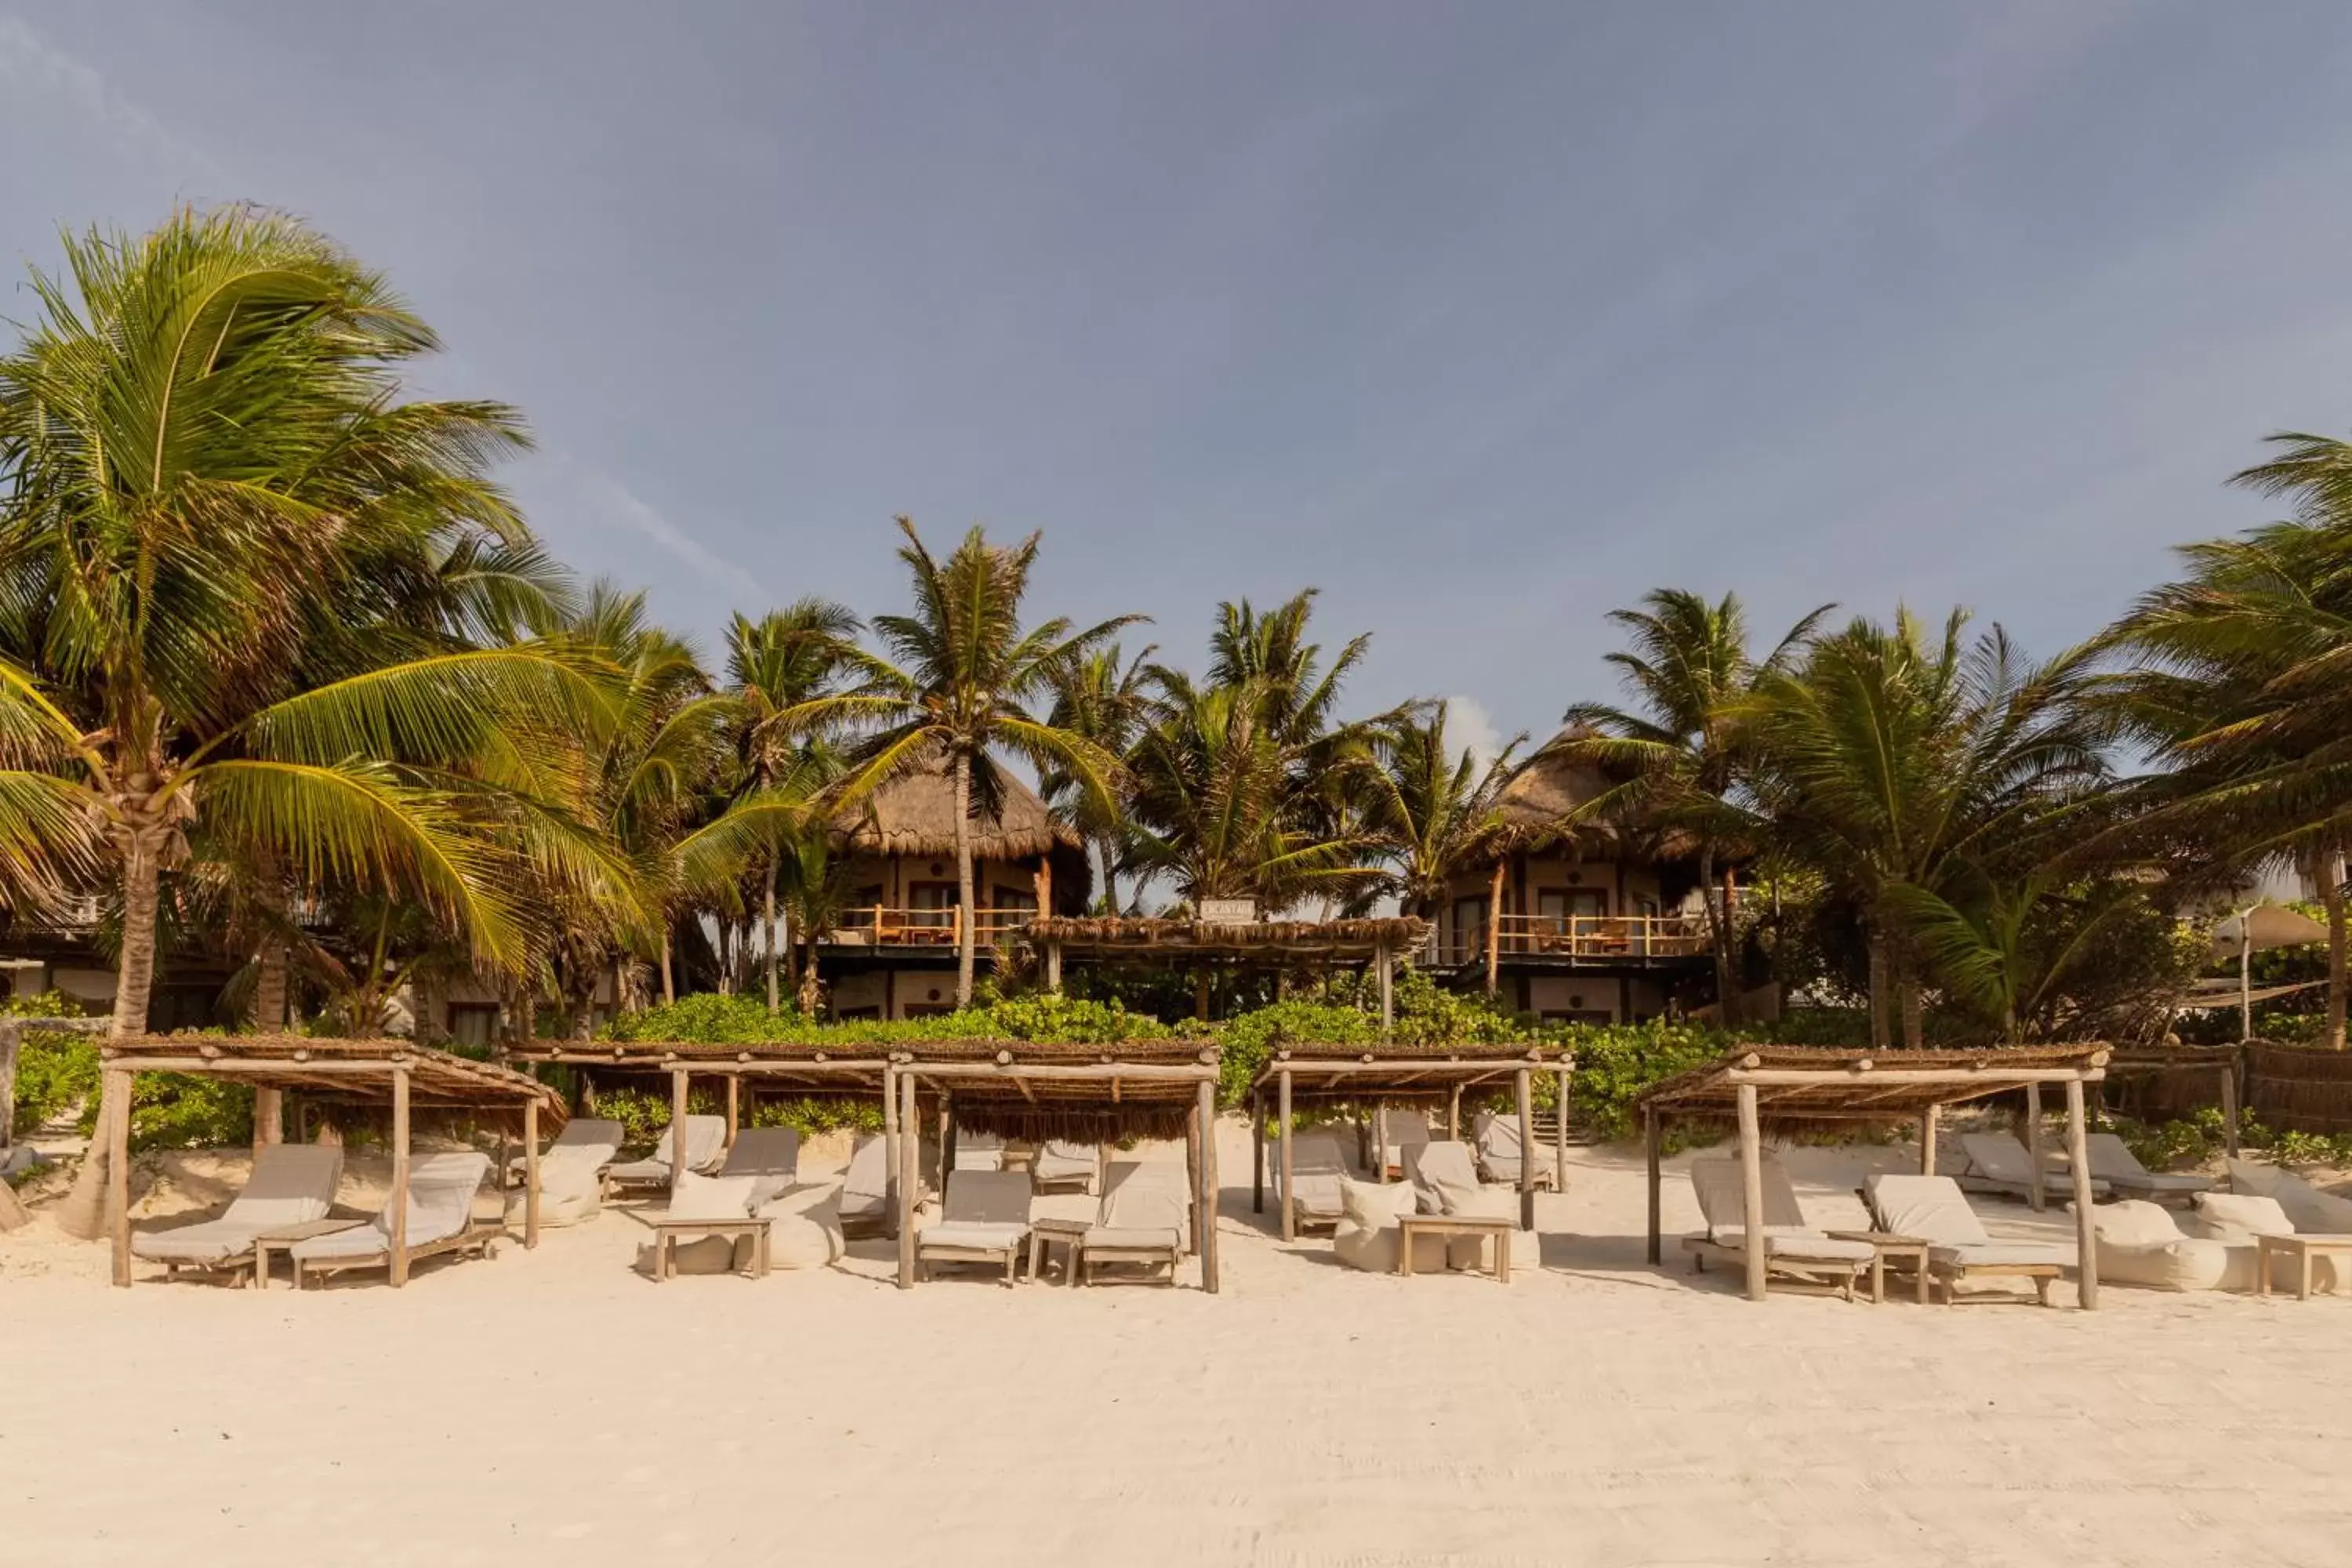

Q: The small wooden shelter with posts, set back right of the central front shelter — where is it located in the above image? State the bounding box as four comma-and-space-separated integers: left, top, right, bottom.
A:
1249, 1044, 1576, 1241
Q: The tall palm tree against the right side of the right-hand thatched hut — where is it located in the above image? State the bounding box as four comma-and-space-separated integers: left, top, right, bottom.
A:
1552, 588, 1832, 1022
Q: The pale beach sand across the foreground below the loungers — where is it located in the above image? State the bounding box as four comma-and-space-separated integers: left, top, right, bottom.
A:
0, 1126, 2352, 1568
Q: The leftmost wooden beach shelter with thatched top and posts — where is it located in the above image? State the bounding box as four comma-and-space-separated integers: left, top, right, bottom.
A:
99, 1034, 567, 1286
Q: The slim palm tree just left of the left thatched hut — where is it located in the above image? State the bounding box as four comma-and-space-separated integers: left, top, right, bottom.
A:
727, 600, 858, 1013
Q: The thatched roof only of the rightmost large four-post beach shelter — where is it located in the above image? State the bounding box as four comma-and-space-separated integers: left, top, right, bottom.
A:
1637, 1041, 2110, 1126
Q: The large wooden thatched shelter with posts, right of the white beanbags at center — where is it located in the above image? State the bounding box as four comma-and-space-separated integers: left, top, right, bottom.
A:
1637, 1044, 2110, 1307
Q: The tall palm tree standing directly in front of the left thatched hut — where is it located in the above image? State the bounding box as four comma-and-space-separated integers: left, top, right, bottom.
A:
833, 517, 1141, 1006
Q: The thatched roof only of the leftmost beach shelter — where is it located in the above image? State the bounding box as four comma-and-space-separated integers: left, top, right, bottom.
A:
99, 1034, 569, 1133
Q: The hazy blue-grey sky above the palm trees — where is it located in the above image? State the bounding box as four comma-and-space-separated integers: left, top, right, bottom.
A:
0, 0, 2352, 761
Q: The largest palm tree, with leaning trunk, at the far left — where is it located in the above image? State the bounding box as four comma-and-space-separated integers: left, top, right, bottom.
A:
0, 209, 600, 1234
